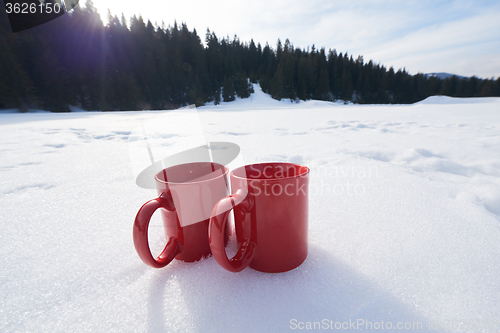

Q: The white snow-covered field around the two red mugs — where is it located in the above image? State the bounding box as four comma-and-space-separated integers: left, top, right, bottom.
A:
0, 87, 500, 332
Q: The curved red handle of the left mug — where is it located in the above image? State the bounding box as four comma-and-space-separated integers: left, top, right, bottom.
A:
134, 191, 180, 268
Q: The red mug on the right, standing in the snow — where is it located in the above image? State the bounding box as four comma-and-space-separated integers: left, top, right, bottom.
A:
208, 163, 310, 273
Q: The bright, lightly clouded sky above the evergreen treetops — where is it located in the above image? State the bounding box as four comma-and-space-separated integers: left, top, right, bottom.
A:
90, 0, 500, 78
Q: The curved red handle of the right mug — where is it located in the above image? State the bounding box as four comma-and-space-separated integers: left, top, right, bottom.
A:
208, 189, 256, 272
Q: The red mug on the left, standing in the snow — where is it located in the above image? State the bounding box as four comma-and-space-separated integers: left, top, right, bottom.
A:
133, 162, 229, 268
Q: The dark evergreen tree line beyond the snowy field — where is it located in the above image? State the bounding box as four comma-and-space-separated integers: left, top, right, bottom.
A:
0, 1, 500, 112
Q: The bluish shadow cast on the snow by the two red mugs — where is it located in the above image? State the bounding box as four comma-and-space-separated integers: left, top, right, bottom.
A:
148, 245, 436, 332
